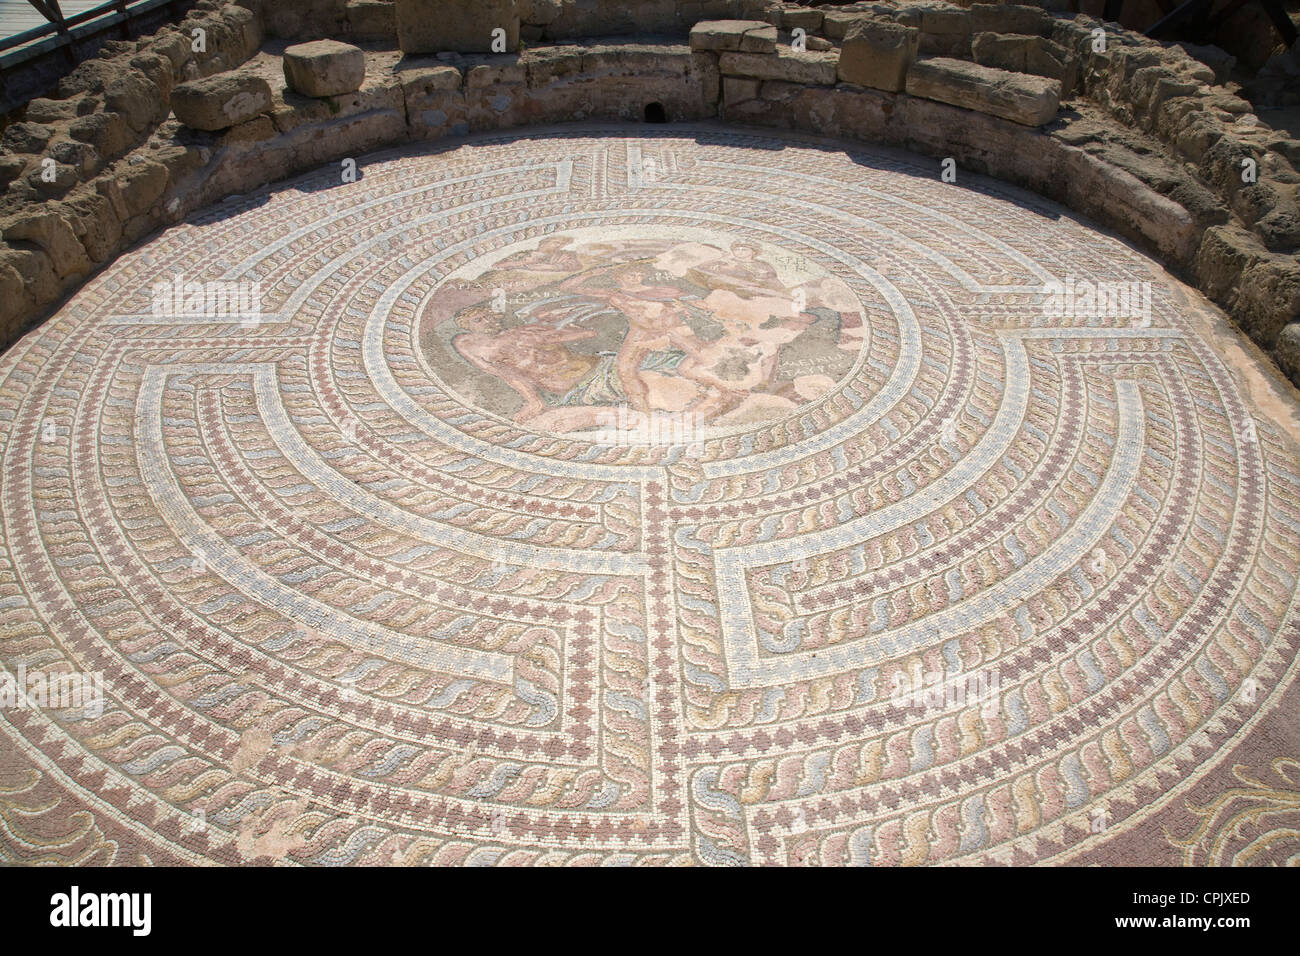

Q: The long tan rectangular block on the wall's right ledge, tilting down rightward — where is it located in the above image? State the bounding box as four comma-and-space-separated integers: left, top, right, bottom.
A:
906, 57, 1061, 126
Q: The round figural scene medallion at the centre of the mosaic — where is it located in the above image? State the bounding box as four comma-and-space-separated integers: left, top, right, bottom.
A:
421, 226, 866, 437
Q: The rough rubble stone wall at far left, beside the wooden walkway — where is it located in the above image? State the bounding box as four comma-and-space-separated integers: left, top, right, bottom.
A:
0, 0, 263, 345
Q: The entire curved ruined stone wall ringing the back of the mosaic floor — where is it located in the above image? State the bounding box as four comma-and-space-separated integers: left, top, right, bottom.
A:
0, 0, 1300, 390
